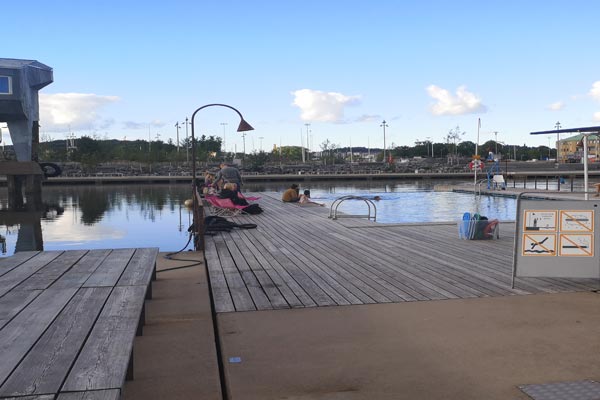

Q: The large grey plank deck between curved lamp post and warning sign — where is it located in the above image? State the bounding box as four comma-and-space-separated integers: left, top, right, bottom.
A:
206, 193, 598, 312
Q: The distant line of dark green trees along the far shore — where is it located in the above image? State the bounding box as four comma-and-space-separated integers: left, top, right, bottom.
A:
38, 135, 556, 166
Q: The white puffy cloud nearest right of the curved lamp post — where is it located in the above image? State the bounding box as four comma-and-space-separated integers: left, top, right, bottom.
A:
292, 89, 360, 122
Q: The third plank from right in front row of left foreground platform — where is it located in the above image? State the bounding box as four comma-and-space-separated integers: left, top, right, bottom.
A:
0, 289, 77, 382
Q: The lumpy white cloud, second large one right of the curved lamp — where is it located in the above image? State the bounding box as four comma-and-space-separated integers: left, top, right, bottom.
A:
427, 85, 486, 115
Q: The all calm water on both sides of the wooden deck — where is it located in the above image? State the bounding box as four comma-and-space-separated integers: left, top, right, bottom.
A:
0, 181, 516, 256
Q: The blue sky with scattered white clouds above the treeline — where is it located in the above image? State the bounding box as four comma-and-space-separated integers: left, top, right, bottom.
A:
0, 0, 600, 153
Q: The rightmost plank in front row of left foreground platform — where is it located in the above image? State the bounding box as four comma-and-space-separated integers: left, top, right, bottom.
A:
61, 286, 145, 392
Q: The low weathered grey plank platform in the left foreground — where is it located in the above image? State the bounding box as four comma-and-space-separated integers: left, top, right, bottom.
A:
0, 248, 158, 400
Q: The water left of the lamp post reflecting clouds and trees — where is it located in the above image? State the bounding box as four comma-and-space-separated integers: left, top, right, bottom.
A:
0, 185, 191, 256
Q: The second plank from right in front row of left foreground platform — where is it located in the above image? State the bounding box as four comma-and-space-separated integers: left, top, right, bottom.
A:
0, 287, 111, 396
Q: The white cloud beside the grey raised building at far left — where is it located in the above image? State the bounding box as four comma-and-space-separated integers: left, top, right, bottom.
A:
40, 93, 119, 132
